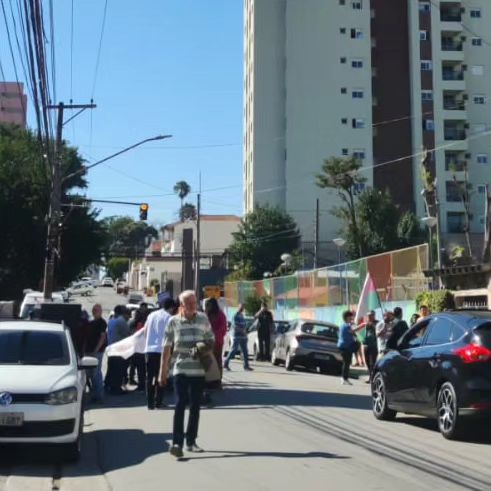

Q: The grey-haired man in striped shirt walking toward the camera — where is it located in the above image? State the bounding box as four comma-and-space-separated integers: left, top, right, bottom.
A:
159, 290, 214, 458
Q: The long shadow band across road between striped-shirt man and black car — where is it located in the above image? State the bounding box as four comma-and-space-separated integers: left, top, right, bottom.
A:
213, 387, 371, 410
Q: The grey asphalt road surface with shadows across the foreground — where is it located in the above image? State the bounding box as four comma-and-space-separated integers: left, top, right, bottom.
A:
0, 291, 491, 491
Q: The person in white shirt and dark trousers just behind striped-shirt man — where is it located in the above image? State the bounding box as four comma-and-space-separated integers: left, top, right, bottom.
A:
144, 298, 178, 409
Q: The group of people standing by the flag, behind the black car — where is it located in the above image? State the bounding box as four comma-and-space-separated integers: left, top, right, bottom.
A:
338, 305, 430, 385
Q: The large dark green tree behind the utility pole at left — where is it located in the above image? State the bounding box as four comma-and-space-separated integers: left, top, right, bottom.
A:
0, 125, 105, 298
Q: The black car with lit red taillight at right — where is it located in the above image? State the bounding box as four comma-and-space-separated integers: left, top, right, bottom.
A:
372, 311, 491, 439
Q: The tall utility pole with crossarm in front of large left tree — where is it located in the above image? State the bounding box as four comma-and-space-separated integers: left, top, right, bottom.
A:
43, 102, 96, 300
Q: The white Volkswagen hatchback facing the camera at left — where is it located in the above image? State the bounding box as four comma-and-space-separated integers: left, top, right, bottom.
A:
0, 321, 98, 461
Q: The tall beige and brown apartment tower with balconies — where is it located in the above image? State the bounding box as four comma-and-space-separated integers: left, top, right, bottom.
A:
244, 0, 491, 260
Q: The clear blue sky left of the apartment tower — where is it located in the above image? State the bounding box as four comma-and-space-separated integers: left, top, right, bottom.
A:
0, 0, 243, 224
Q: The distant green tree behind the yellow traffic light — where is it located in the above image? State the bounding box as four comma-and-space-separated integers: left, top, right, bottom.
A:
104, 216, 158, 259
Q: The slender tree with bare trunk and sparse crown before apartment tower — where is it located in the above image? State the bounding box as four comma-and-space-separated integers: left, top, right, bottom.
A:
316, 157, 366, 257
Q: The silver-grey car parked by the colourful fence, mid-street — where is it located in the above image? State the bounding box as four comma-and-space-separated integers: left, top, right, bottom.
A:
271, 319, 343, 374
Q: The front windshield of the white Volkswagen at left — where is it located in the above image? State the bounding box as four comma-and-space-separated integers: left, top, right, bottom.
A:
0, 330, 70, 365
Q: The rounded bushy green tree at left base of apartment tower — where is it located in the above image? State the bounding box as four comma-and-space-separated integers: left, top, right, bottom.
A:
228, 206, 300, 280
